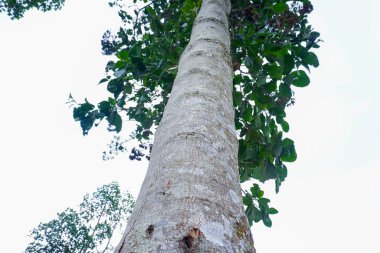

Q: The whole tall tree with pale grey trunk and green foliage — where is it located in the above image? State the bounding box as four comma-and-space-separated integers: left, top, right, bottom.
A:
2, 0, 320, 252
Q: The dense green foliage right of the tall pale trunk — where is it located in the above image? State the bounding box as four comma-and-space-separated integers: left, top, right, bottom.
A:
230, 0, 320, 226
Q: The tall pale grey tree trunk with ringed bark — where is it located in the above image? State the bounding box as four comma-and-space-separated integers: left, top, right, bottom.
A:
115, 0, 255, 253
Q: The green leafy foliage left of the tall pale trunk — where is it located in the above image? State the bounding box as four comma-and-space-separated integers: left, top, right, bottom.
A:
72, 0, 201, 160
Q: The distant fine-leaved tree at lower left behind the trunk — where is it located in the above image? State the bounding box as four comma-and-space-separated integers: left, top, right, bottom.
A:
25, 182, 134, 253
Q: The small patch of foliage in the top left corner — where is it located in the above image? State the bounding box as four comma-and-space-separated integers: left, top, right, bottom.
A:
0, 0, 65, 19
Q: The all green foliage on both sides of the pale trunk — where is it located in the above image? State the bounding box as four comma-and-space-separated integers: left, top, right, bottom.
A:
67, 0, 320, 226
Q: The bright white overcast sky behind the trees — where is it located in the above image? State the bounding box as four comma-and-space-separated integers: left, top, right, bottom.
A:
0, 0, 380, 253
